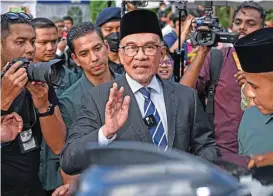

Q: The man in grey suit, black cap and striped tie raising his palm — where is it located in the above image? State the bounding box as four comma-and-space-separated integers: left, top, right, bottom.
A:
61, 10, 217, 174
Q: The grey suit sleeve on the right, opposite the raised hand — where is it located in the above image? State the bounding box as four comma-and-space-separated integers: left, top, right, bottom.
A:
191, 92, 218, 161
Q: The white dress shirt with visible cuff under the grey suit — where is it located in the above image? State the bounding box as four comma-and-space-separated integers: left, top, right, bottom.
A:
98, 73, 168, 146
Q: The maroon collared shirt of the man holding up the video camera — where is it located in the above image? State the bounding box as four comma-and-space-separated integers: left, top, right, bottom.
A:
196, 48, 243, 155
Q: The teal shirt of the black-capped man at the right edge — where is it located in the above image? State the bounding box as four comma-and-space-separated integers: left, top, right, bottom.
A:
238, 106, 273, 155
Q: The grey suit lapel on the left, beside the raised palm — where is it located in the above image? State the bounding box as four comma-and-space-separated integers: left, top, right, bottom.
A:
118, 74, 152, 142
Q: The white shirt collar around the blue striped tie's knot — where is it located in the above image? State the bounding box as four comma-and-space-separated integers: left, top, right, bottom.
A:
125, 73, 161, 93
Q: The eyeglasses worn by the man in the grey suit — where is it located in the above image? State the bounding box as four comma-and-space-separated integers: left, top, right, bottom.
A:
120, 45, 162, 57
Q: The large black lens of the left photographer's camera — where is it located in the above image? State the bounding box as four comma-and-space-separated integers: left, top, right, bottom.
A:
27, 59, 65, 85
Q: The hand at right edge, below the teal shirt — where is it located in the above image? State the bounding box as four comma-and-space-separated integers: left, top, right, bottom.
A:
248, 152, 273, 169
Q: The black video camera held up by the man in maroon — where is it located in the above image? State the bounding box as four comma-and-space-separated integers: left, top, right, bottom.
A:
190, 1, 238, 46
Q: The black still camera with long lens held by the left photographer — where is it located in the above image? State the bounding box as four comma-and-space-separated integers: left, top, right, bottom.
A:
1, 57, 65, 86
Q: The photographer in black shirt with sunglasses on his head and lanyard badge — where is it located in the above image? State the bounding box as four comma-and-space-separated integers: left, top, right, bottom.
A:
1, 12, 66, 196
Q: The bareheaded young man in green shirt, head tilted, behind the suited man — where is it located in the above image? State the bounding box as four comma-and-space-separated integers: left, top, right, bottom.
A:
55, 22, 119, 194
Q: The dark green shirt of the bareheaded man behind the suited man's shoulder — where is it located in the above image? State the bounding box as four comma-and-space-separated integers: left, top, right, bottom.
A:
59, 71, 120, 131
